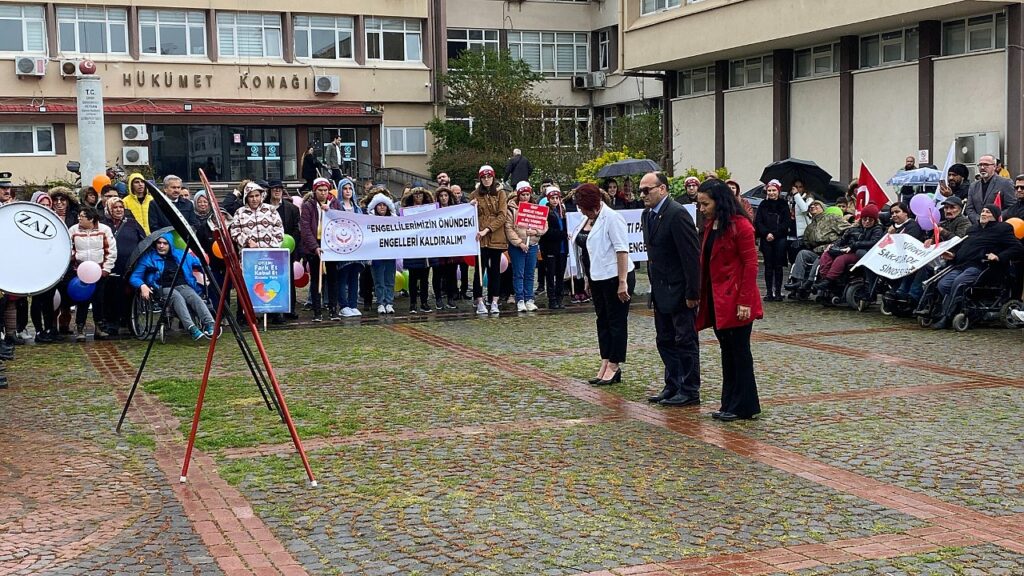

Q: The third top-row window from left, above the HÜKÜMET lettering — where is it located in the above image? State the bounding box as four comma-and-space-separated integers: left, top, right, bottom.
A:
138, 10, 206, 56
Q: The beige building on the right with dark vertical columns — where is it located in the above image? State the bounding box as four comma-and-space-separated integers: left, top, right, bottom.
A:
623, 0, 1024, 188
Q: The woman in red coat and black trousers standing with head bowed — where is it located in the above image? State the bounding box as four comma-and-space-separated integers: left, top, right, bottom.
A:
697, 179, 764, 422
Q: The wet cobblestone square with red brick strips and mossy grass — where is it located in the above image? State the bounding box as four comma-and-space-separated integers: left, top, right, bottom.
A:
0, 302, 1024, 576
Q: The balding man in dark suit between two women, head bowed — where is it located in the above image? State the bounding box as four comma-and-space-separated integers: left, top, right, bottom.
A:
640, 172, 700, 406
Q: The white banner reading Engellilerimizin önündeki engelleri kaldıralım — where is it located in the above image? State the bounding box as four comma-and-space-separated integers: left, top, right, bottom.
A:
321, 204, 480, 261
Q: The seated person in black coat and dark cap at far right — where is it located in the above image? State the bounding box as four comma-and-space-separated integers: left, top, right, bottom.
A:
932, 204, 1024, 330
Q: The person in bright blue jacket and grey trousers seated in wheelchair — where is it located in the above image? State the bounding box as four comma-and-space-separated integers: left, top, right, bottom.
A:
129, 235, 214, 340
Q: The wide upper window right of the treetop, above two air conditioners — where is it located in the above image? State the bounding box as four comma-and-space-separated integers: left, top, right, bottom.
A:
509, 32, 590, 78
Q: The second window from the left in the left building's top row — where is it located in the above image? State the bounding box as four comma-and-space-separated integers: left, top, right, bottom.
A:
57, 6, 128, 54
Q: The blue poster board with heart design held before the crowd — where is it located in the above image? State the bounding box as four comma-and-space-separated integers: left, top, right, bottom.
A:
242, 248, 292, 314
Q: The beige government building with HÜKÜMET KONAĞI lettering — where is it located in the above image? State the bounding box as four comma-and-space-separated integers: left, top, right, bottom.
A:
0, 0, 662, 182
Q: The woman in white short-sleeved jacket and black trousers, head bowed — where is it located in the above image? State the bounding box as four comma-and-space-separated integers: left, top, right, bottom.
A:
571, 183, 636, 385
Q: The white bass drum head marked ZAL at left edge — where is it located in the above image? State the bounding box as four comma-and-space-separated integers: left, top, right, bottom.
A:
0, 202, 71, 296
